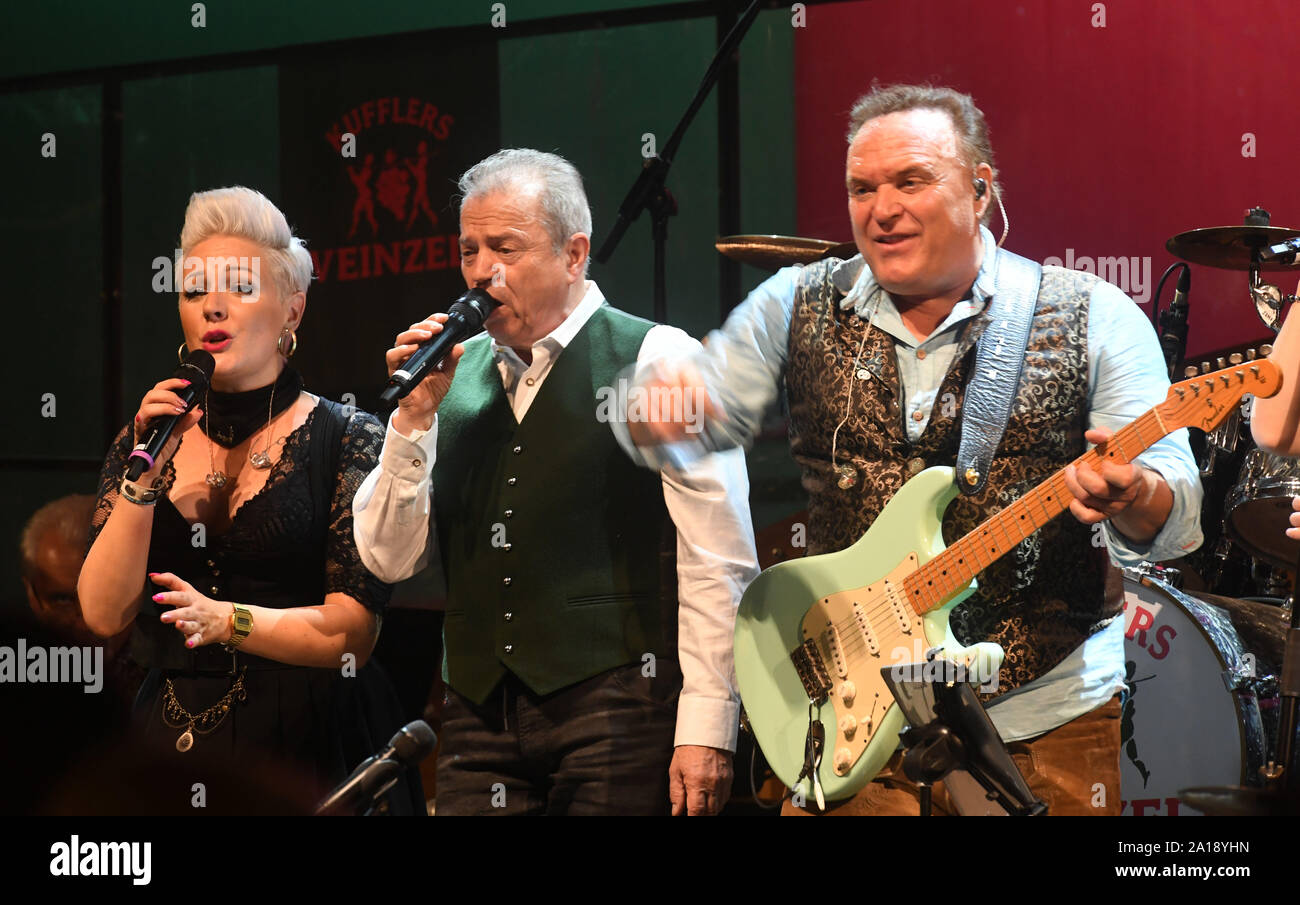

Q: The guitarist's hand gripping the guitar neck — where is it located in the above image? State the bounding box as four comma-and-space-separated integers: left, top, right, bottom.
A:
1065, 428, 1174, 544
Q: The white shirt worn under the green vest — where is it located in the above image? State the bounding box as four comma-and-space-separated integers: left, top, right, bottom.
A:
352, 281, 758, 752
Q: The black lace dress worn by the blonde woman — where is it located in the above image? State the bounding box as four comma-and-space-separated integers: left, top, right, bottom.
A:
91, 399, 423, 813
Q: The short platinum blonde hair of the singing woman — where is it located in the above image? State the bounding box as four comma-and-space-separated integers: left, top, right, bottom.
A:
181, 186, 312, 295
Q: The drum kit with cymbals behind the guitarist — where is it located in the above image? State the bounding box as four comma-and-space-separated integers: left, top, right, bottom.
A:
716, 208, 1300, 815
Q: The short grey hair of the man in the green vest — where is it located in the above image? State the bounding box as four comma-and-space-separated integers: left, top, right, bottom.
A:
459, 148, 592, 260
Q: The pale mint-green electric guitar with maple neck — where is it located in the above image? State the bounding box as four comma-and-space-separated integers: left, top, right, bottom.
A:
736, 352, 1282, 801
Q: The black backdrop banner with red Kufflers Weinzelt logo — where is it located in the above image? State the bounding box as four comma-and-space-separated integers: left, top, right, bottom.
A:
280, 43, 501, 411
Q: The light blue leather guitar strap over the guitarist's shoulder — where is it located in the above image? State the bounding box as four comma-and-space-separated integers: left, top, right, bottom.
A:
956, 248, 1043, 494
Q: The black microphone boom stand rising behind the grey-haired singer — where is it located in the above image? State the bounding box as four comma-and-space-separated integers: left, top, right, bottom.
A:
593, 0, 758, 322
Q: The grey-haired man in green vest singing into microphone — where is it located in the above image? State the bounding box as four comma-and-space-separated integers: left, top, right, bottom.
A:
354, 150, 758, 814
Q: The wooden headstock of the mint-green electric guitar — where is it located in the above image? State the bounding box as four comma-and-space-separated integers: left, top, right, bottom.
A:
1156, 346, 1282, 433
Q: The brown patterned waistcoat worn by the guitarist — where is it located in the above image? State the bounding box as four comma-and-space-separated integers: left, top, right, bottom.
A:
785, 259, 1123, 693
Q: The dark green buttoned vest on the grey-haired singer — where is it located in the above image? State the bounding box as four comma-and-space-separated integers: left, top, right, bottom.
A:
433, 306, 677, 703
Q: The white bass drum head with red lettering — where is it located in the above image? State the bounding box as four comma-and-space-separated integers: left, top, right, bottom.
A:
1119, 575, 1264, 817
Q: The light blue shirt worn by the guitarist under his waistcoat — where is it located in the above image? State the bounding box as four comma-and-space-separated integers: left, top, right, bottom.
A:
614, 228, 1201, 741
